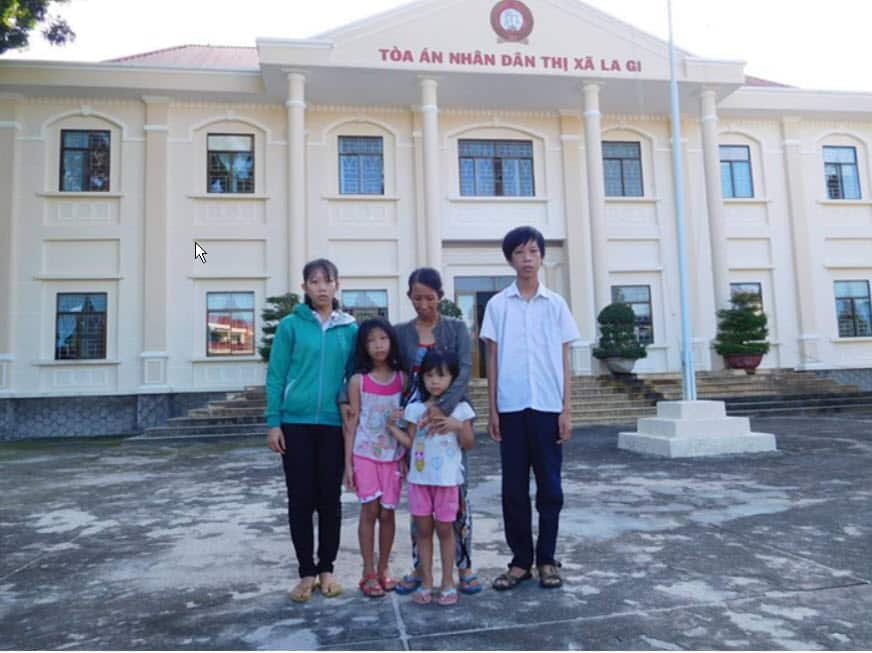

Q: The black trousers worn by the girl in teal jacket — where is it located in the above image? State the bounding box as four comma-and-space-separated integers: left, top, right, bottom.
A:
282, 424, 345, 578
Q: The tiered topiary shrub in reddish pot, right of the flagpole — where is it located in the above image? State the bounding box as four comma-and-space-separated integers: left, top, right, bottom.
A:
715, 293, 769, 374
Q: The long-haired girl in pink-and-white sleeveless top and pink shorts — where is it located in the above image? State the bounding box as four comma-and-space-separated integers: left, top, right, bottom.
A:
345, 318, 406, 598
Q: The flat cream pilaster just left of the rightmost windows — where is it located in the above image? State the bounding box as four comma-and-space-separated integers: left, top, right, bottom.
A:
781, 116, 822, 369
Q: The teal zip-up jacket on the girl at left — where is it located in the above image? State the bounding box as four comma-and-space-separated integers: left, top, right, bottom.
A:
264, 304, 357, 428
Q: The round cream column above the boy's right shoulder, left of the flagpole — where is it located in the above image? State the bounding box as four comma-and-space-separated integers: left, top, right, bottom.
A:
584, 84, 612, 313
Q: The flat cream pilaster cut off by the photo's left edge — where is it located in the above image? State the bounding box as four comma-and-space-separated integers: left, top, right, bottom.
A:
0, 94, 21, 396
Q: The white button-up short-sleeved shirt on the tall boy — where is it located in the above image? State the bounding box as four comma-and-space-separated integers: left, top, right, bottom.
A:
480, 283, 580, 413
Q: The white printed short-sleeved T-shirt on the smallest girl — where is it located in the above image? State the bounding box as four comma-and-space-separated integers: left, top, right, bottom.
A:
403, 401, 475, 487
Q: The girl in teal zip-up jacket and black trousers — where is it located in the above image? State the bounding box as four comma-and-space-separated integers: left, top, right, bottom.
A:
264, 259, 357, 602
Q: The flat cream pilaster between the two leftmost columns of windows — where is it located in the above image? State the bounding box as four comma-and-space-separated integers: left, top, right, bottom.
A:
140, 96, 170, 390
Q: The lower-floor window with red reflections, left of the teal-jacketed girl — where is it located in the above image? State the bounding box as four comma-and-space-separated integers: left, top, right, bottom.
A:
206, 292, 254, 356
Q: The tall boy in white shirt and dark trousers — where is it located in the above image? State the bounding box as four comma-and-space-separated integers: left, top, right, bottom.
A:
481, 227, 579, 590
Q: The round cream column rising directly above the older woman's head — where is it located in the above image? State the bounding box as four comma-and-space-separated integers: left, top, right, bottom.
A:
421, 79, 442, 270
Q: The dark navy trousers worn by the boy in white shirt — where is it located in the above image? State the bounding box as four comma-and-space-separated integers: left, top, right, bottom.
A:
500, 408, 563, 569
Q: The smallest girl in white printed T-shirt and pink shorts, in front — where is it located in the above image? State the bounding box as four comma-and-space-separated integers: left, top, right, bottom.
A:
389, 348, 475, 606
